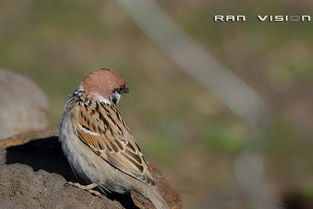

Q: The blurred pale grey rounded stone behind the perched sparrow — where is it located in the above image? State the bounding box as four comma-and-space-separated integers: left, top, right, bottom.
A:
0, 69, 48, 138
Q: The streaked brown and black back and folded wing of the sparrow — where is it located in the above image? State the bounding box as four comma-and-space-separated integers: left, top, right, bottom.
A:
73, 102, 154, 185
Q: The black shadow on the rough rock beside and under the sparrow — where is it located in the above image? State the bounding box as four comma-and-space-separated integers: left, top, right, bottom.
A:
6, 136, 138, 209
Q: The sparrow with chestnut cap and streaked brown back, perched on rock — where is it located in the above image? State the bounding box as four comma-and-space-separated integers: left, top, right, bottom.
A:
59, 69, 169, 209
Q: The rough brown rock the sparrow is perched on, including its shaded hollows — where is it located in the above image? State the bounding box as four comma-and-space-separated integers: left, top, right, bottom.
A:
0, 130, 181, 209
